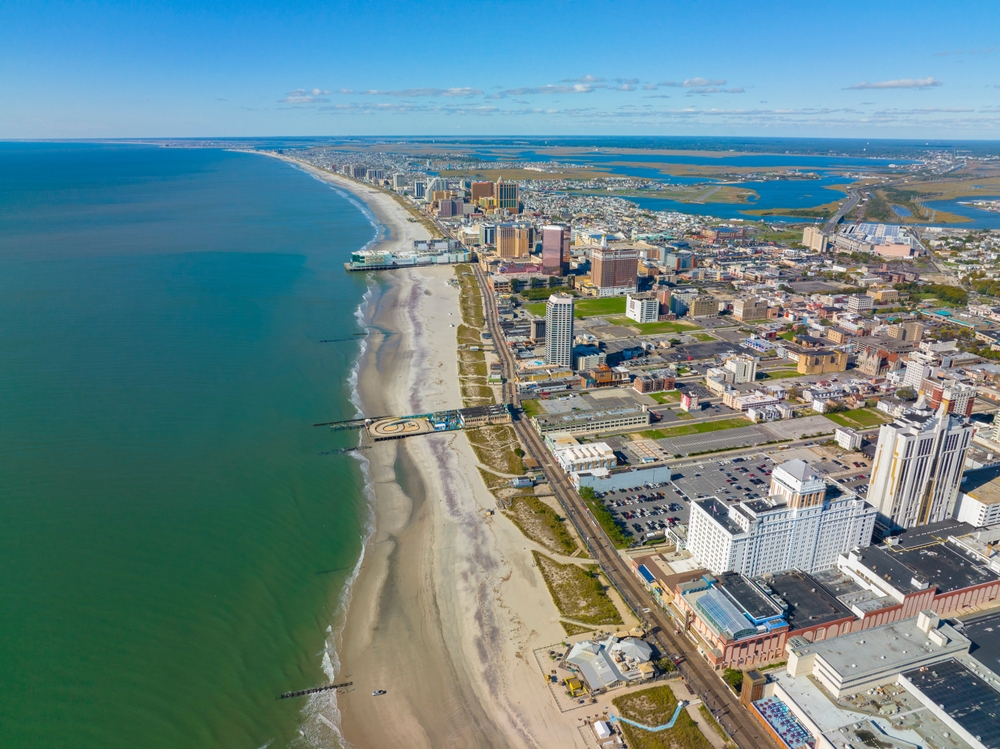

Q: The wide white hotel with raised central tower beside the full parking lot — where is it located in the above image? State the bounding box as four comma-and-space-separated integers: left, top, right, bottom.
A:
687, 460, 875, 577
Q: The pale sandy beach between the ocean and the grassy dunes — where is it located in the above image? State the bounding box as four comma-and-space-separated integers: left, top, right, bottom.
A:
268, 159, 585, 749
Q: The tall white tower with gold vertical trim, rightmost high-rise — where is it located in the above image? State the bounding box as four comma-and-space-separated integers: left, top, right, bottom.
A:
868, 402, 973, 530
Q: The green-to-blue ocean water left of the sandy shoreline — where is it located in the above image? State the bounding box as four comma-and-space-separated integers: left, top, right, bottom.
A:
0, 143, 375, 749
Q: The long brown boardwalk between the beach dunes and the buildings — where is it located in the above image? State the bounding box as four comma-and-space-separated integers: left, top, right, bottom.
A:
473, 265, 775, 749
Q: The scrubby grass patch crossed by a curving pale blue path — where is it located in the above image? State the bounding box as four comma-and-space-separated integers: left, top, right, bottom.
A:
611, 686, 712, 749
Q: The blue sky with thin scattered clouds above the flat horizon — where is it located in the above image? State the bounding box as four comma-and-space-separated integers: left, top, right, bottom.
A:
0, 0, 1000, 139
